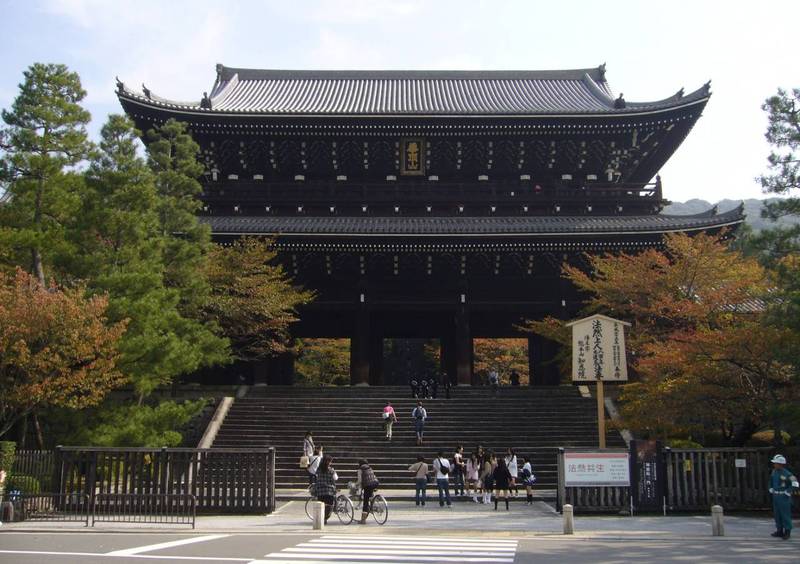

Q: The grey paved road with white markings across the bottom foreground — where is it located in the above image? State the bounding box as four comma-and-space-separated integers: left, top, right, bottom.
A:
0, 528, 798, 564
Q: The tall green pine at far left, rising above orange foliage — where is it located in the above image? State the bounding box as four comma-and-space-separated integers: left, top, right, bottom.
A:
0, 63, 92, 286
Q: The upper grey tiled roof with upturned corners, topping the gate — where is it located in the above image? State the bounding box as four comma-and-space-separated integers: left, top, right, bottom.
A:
119, 65, 709, 115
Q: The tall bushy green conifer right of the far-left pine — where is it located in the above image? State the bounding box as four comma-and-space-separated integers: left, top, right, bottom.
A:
70, 115, 227, 402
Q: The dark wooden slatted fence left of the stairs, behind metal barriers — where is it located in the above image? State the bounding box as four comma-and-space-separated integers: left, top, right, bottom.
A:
52, 447, 275, 513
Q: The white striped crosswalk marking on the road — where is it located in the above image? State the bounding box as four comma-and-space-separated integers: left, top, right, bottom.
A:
250, 535, 517, 564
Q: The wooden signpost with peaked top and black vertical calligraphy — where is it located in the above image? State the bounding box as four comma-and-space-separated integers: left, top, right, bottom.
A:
567, 314, 631, 448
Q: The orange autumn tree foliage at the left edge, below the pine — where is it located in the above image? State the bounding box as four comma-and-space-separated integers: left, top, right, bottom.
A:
0, 269, 126, 436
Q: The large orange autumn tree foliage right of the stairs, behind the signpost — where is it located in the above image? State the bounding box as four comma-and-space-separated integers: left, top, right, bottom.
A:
532, 234, 800, 444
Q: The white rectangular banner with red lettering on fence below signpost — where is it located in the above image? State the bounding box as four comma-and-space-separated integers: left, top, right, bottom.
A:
564, 452, 631, 488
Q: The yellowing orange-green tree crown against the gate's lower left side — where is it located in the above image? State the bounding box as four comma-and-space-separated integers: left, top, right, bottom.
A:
205, 237, 313, 360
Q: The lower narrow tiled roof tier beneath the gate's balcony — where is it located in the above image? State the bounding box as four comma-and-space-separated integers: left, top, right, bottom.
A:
201, 207, 744, 237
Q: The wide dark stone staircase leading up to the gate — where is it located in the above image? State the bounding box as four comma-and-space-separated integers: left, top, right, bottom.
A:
214, 386, 625, 489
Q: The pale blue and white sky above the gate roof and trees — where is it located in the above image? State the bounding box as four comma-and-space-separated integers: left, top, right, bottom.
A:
0, 0, 800, 202
